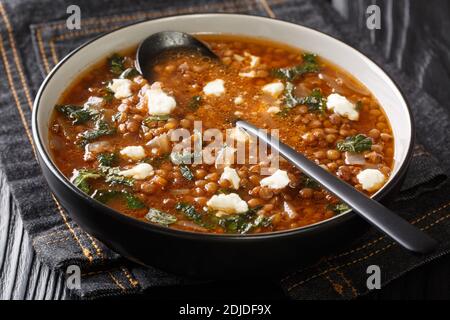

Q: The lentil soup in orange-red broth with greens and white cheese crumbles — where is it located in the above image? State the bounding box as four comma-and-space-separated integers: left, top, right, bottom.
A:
49, 35, 394, 234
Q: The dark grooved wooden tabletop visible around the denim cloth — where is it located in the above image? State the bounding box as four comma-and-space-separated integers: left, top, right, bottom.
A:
0, 0, 450, 299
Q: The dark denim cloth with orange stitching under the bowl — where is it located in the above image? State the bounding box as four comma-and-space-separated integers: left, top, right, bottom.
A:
0, 0, 450, 299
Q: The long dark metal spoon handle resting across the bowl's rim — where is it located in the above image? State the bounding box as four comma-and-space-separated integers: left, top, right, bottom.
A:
236, 121, 437, 253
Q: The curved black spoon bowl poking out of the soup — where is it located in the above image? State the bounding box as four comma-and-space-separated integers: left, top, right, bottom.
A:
136, 31, 218, 80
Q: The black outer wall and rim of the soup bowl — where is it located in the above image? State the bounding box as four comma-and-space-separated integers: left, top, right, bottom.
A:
32, 14, 414, 278
